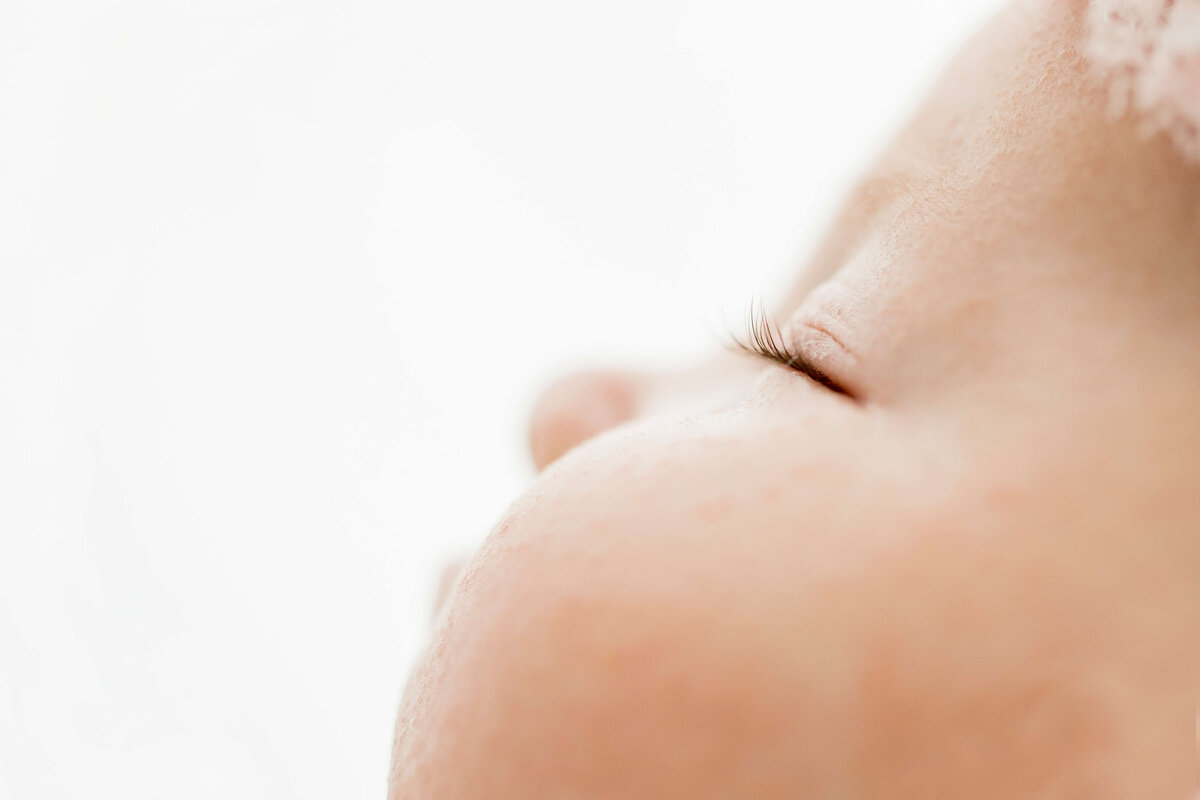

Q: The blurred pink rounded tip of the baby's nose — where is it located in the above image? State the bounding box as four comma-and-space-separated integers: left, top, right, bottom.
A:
529, 372, 637, 470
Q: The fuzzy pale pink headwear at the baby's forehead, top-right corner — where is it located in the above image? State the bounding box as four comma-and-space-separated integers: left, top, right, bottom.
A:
1087, 0, 1200, 166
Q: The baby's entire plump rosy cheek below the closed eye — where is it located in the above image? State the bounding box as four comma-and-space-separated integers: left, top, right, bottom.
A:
392, 412, 1194, 800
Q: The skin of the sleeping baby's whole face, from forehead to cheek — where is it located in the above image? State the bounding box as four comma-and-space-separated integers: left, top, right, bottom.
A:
390, 0, 1200, 800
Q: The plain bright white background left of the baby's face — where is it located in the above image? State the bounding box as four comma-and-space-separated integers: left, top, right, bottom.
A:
0, 0, 997, 800
